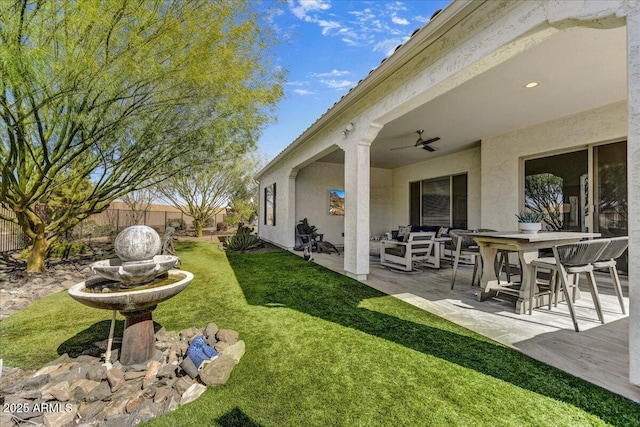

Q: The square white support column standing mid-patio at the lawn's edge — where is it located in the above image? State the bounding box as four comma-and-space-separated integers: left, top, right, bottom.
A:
344, 141, 371, 280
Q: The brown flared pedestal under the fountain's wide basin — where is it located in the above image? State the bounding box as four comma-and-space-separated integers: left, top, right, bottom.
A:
120, 305, 156, 366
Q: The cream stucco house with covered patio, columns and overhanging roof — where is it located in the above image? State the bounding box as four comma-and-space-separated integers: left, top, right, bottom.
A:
257, 0, 640, 392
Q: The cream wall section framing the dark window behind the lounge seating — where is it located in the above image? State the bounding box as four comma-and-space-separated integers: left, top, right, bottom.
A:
390, 148, 480, 229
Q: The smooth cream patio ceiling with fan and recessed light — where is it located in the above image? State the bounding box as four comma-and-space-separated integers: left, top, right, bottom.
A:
319, 27, 627, 169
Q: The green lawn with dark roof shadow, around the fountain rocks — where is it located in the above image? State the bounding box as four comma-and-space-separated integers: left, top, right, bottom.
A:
0, 243, 640, 427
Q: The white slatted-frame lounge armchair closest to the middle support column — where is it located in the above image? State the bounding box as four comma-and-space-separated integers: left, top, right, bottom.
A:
380, 231, 436, 271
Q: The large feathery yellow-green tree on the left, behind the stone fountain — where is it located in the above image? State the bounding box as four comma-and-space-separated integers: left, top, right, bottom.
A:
0, 0, 283, 271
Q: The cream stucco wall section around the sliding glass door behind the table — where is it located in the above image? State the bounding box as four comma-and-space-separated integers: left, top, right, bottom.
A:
481, 102, 627, 230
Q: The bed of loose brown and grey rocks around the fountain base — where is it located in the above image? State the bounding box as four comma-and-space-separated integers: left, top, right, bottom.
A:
0, 323, 245, 427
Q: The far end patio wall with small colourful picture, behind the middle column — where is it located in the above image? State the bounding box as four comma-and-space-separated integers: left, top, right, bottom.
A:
295, 162, 392, 245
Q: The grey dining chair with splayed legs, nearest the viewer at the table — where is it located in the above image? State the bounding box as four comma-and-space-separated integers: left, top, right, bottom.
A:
529, 239, 610, 332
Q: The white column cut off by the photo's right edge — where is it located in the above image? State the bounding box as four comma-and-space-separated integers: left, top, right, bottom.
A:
627, 7, 640, 386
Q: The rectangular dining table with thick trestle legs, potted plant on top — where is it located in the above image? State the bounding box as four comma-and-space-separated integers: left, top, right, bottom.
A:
469, 231, 600, 314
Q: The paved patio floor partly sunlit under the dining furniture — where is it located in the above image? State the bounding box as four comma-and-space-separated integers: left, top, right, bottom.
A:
294, 252, 640, 402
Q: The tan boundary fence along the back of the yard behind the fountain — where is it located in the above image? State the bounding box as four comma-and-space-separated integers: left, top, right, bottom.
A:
0, 208, 224, 252
